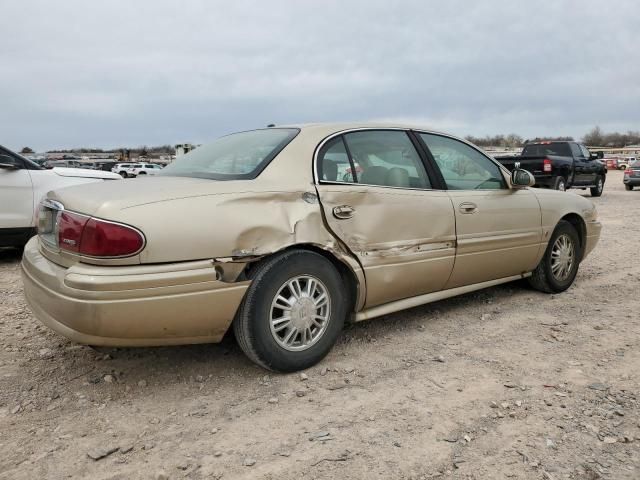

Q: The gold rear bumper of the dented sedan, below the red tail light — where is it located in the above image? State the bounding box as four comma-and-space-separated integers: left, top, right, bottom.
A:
22, 237, 249, 346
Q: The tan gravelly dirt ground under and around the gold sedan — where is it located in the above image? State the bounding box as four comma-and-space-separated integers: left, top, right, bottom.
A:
0, 172, 640, 479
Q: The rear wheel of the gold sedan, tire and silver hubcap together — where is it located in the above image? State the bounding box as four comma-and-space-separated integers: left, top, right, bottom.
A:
233, 250, 347, 372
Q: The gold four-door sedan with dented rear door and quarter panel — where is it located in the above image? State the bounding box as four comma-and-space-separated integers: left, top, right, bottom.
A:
22, 124, 601, 371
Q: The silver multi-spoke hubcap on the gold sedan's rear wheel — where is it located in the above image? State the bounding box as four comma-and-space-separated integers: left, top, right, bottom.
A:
269, 275, 331, 351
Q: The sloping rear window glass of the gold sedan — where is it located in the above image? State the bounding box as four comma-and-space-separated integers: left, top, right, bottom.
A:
158, 128, 299, 180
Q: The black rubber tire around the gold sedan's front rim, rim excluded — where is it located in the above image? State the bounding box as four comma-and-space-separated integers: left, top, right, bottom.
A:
527, 220, 582, 293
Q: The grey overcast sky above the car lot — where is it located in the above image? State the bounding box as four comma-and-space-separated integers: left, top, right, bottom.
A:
0, 0, 640, 151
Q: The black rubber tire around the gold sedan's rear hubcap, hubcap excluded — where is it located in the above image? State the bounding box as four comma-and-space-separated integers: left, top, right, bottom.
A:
233, 250, 348, 372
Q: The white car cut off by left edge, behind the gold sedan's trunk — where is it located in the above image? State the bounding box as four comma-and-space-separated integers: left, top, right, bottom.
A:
0, 146, 120, 247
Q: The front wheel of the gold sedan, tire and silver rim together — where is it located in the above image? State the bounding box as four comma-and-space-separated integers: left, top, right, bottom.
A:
528, 220, 582, 293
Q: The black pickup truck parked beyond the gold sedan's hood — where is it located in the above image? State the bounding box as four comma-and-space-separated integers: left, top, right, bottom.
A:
496, 141, 607, 197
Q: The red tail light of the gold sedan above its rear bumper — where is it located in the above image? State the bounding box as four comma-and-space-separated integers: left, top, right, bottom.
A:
58, 211, 144, 257
